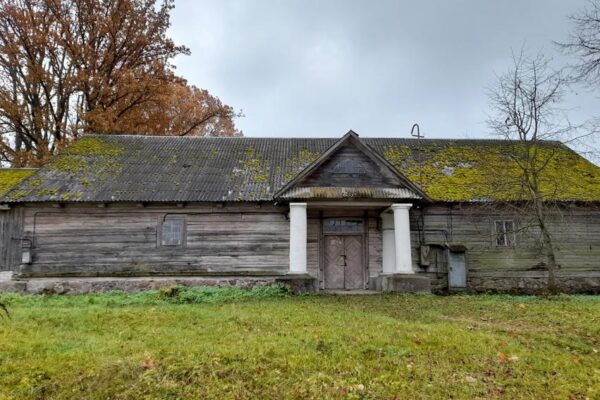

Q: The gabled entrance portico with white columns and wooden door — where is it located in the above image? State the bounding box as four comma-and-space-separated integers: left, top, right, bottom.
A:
276, 131, 427, 290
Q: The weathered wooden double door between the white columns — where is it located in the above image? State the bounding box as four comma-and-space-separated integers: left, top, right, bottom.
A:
323, 235, 365, 290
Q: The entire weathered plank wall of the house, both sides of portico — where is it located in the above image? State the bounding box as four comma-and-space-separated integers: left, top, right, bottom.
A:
10, 204, 600, 292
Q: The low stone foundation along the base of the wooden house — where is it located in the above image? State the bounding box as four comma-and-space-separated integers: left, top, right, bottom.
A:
0, 273, 600, 294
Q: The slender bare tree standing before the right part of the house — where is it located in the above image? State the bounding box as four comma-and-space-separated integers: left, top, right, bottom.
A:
488, 51, 574, 292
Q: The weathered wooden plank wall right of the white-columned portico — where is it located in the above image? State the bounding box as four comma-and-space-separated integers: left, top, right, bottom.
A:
411, 205, 600, 290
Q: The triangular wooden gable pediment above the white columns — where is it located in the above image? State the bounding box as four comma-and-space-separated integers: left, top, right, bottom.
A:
275, 131, 427, 199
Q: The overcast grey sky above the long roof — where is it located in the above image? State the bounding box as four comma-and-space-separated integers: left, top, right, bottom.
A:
171, 0, 600, 138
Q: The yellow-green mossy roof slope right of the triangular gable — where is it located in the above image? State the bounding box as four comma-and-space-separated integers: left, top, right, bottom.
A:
384, 143, 600, 201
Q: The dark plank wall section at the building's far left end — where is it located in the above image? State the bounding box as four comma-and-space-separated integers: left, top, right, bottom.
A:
0, 208, 23, 271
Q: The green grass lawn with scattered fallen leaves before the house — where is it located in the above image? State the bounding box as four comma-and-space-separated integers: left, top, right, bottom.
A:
0, 290, 600, 399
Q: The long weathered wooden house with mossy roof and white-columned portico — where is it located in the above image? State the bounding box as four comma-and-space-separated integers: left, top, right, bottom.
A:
0, 131, 600, 293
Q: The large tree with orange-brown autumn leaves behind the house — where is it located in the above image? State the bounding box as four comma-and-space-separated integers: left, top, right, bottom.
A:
0, 0, 240, 166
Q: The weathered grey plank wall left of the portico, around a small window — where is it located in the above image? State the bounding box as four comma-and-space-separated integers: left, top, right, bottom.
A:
22, 205, 289, 276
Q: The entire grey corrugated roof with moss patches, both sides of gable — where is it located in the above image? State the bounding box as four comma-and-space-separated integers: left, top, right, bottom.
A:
2, 135, 600, 202
